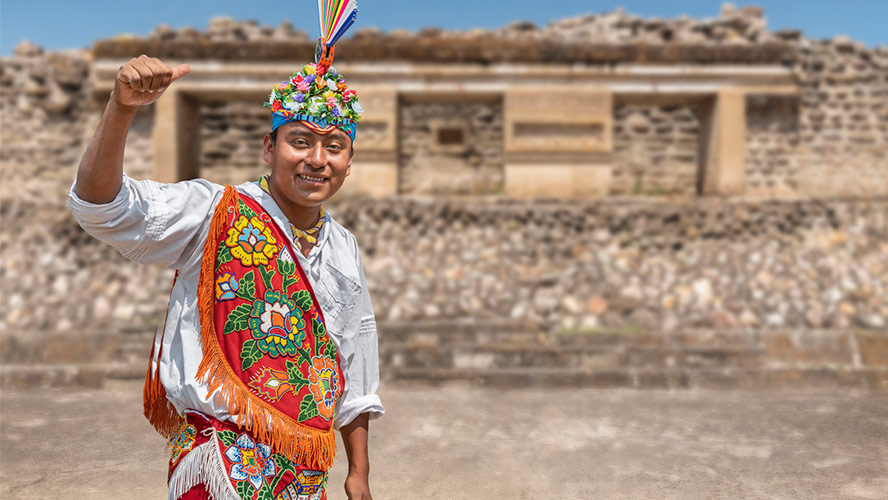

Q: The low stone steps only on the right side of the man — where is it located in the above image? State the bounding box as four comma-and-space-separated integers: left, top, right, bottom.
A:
380, 321, 888, 389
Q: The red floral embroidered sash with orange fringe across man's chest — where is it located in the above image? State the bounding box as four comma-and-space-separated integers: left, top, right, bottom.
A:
145, 186, 344, 471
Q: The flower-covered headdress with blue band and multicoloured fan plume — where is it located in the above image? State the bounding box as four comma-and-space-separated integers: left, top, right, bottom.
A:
265, 0, 364, 141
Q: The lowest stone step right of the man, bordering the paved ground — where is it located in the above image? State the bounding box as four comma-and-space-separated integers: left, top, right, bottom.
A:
383, 366, 888, 391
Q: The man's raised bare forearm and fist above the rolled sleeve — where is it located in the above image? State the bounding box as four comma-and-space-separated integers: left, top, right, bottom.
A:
75, 55, 191, 204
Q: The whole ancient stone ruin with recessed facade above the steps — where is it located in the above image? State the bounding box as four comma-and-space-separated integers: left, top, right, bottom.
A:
0, 5, 888, 364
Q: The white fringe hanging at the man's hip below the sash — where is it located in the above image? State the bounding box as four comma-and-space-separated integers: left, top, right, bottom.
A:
168, 429, 241, 500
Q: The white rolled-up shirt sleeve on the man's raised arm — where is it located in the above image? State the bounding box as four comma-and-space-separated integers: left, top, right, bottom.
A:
67, 175, 222, 267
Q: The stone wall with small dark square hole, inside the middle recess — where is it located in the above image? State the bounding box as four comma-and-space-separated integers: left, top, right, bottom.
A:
398, 102, 503, 194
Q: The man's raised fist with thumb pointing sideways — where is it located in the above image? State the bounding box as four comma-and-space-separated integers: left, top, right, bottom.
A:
113, 54, 191, 107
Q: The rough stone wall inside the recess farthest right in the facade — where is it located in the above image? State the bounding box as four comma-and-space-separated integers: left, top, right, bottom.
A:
610, 104, 700, 196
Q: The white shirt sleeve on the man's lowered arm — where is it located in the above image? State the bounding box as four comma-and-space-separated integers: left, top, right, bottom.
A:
333, 248, 385, 429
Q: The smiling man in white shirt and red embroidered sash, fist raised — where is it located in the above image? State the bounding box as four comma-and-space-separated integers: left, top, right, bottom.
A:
68, 55, 384, 500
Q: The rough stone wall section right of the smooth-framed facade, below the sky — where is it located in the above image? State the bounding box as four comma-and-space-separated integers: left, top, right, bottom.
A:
794, 37, 888, 197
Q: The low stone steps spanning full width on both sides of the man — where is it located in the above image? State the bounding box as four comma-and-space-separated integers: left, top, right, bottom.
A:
0, 320, 888, 390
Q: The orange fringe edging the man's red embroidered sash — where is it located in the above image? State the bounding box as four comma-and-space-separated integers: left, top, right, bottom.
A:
193, 186, 336, 470
